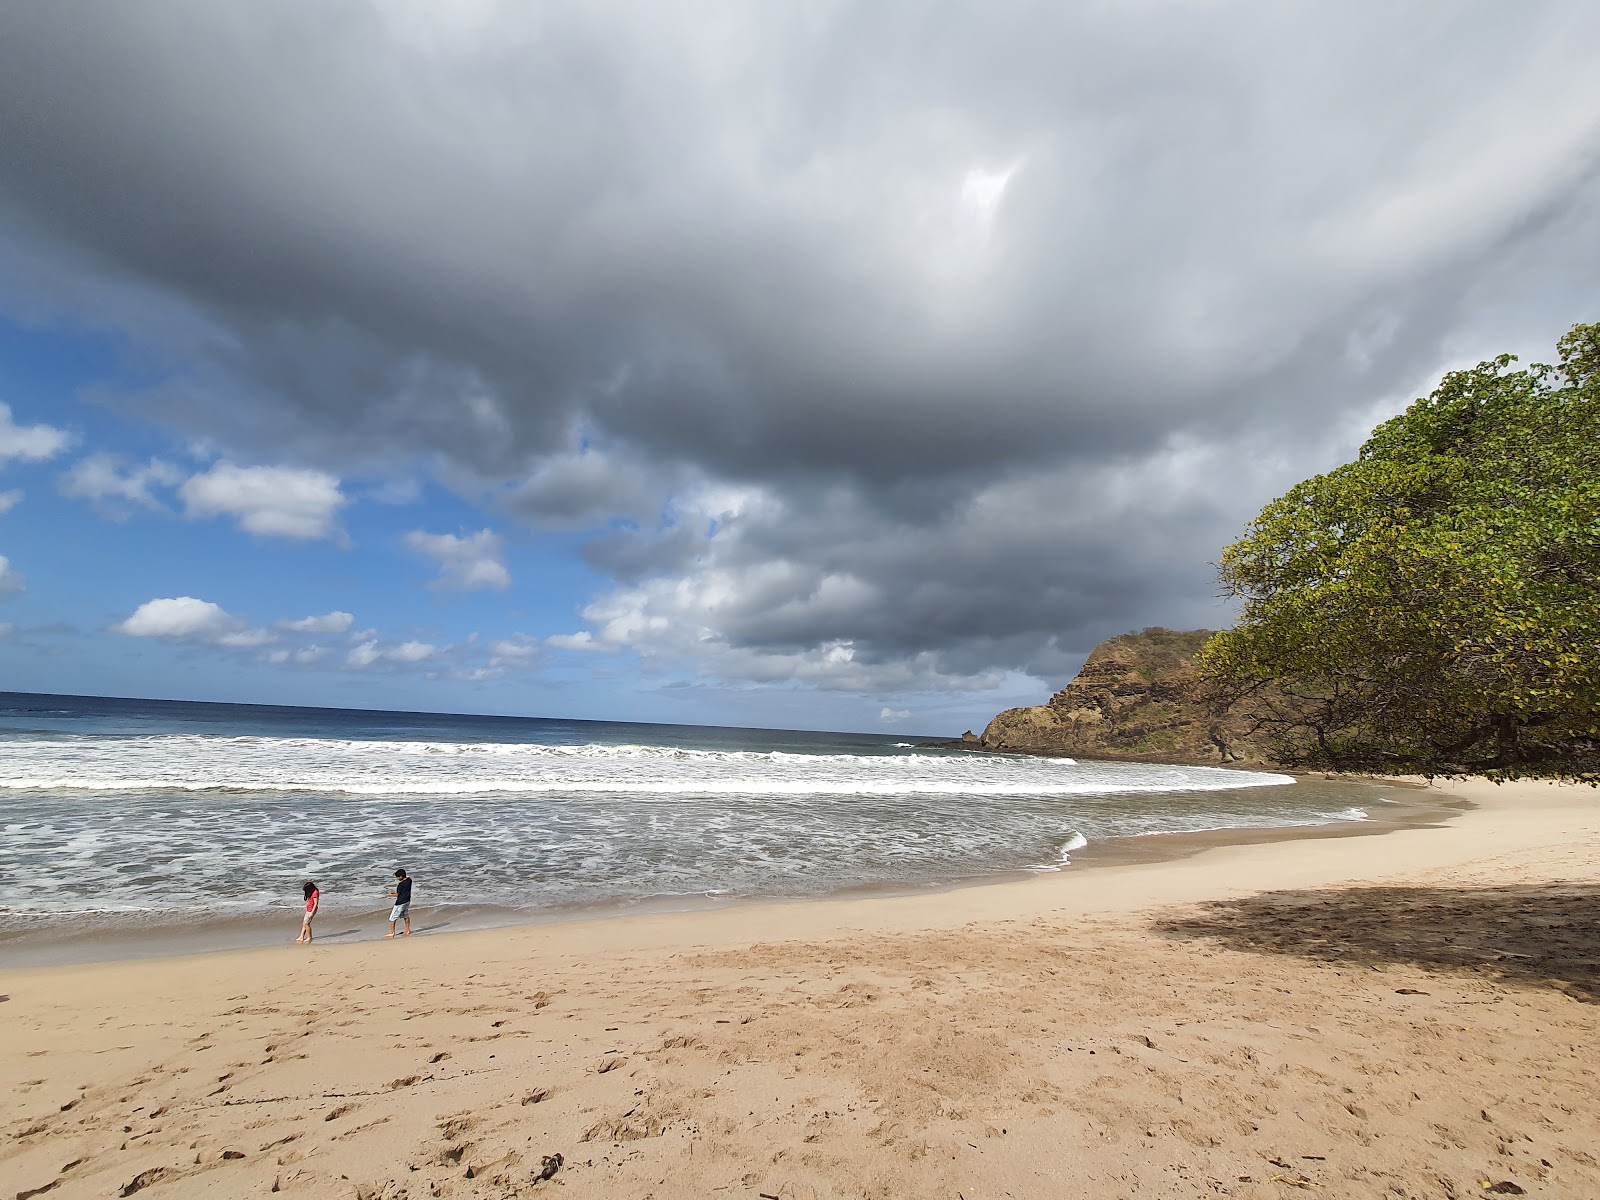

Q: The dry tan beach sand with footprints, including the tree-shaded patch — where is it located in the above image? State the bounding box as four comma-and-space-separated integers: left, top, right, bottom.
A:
0, 784, 1600, 1200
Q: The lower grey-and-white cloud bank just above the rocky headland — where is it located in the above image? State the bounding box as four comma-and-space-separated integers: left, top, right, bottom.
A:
586, 443, 1282, 690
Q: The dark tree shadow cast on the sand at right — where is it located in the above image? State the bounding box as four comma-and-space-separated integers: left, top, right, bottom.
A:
1155, 883, 1600, 1005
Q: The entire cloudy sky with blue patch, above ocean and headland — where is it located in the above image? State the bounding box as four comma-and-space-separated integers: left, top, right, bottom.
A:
0, 0, 1600, 734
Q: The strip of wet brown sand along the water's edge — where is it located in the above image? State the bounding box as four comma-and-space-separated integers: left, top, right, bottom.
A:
0, 774, 1452, 971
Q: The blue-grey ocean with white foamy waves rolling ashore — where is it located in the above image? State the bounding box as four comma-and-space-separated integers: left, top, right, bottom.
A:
0, 693, 1376, 949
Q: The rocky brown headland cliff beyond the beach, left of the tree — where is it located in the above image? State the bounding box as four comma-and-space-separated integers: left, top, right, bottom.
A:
976, 629, 1264, 766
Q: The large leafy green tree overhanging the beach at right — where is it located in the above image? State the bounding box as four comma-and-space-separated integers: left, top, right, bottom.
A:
1200, 325, 1600, 782
